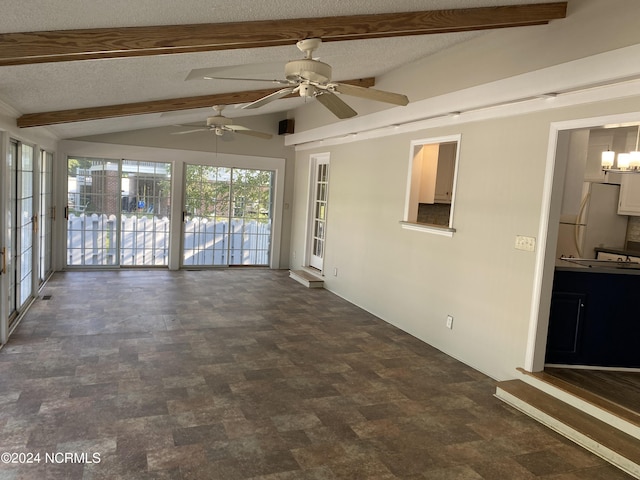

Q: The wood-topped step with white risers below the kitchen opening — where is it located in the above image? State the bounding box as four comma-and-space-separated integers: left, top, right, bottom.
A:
496, 372, 640, 479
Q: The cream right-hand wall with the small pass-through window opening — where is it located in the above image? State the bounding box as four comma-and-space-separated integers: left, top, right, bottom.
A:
292, 96, 640, 379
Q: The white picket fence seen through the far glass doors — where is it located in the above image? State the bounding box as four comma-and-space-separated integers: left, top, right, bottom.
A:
67, 214, 271, 266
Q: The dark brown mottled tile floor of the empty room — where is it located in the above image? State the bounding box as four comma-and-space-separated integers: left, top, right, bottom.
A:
0, 269, 630, 480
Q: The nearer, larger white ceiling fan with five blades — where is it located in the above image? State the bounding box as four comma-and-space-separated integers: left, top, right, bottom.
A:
204, 38, 409, 118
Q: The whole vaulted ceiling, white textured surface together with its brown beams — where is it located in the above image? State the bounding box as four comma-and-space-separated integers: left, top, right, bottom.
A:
0, 0, 566, 138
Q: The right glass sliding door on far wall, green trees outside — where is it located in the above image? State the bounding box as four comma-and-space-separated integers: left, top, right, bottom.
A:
182, 165, 274, 266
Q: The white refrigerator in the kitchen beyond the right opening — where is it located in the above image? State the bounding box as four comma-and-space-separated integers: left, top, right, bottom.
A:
557, 182, 629, 258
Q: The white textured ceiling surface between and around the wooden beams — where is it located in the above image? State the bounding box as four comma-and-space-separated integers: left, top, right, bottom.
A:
0, 0, 548, 138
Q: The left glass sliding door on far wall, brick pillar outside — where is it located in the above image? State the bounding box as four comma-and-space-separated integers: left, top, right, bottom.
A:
65, 157, 171, 268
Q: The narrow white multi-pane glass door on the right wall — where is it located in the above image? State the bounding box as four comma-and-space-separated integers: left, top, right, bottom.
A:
307, 154, 329, 272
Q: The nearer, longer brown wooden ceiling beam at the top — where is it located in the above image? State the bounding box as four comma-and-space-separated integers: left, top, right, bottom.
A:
0, 2, 567, 66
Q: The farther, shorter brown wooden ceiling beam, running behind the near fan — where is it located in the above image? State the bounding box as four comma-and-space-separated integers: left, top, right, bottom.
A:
17, 77, 375, 128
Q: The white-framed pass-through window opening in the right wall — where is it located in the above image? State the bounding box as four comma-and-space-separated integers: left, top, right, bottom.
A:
401, 135, 460, 236
